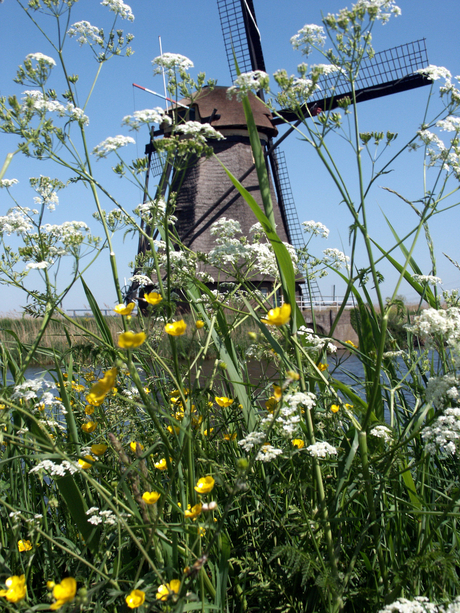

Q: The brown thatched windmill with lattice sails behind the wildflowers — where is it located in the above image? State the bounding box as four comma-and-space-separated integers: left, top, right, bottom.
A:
128, 0, 430, 301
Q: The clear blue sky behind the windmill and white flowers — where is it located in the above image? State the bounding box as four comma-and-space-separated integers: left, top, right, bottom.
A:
0, 0, 460, 313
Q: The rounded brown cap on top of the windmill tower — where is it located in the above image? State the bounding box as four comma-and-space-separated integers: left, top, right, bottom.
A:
176, 86, 278, 137
